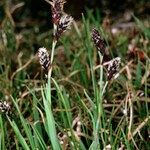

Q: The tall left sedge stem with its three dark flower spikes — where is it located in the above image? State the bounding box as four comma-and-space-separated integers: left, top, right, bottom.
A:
38, 0, 73, 149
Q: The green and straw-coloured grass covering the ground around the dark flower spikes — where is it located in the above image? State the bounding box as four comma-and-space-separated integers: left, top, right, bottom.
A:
0, 2, 150, 150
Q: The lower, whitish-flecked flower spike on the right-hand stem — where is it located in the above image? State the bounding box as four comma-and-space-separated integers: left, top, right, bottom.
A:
107, 57, 121, 80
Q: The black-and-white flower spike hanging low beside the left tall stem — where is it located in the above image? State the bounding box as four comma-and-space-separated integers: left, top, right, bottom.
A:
38, 47, 50, 70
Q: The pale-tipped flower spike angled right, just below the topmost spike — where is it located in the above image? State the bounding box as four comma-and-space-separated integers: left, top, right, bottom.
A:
54, 14, 73, 40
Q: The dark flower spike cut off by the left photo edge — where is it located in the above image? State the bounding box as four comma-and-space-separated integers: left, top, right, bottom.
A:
0, 101, 11, 115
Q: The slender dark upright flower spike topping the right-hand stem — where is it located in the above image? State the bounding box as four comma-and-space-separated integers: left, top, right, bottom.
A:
92, 28, 106, 56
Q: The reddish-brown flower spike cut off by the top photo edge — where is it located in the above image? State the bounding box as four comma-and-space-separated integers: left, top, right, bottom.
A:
51, 0, 66, 25
